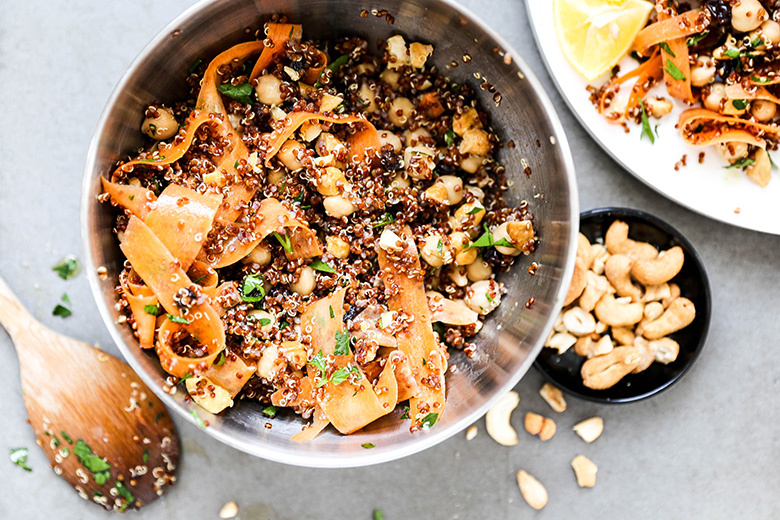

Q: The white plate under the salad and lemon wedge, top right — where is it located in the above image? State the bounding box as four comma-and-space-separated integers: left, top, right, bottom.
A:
525, 0, 780, 235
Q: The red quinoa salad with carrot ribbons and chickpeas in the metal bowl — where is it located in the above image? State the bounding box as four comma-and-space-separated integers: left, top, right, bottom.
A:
100, 16, 538, 442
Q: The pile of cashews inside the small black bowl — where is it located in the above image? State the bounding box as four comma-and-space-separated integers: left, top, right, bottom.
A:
545, 220, 696, 390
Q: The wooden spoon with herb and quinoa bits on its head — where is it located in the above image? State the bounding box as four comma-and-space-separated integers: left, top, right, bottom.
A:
0, 278, 179, 511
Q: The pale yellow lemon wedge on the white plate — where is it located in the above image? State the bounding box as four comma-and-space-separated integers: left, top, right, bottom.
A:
553, 0, 653, 81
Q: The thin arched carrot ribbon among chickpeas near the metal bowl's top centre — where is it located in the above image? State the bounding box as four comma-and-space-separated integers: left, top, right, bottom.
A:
265, 111, 380, 166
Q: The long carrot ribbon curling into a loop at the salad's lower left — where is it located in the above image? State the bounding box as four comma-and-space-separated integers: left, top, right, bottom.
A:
119, 216, 225, 377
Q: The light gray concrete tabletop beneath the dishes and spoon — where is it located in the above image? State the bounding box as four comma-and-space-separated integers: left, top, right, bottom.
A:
0, 0, 780, 520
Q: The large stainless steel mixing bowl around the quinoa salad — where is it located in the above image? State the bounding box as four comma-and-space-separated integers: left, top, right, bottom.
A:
82, 0, 579, 467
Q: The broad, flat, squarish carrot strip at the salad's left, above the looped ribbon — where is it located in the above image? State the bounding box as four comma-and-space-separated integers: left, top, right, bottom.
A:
144, 184, 222, 271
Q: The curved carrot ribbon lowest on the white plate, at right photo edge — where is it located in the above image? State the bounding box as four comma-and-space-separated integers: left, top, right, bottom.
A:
678, 108, 780, 148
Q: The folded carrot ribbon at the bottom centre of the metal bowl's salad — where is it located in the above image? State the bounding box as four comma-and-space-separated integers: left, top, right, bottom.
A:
301, 288, 398, 434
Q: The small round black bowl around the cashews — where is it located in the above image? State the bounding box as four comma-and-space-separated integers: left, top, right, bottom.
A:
535, 208, 712, 403
